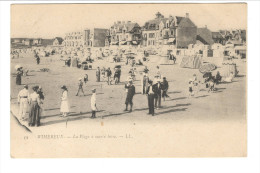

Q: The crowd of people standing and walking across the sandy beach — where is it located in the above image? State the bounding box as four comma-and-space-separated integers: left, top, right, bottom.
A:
13, 45, 239, 126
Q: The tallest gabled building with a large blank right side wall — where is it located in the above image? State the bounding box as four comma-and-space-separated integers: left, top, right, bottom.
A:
142, 12, 197, 48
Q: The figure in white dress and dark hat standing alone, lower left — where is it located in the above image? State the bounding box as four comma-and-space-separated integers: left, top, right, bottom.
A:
60, 85, 70, 117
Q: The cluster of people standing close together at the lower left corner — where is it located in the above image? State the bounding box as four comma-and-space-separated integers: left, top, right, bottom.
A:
18, 85, 44, 126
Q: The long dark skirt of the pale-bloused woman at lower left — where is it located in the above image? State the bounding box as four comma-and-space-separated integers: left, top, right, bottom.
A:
29, 102, 40, 125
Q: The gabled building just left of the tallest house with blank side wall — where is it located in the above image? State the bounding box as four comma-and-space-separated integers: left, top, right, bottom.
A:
106, 21, 142, 46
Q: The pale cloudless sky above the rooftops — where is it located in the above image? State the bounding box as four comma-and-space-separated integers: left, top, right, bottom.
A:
11, 3, 247, 38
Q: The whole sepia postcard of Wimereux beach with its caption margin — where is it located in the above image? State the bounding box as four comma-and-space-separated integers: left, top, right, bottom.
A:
8, 3, 248, 158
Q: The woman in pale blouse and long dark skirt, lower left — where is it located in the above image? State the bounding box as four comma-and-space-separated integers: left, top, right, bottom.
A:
28, 86, 41, 127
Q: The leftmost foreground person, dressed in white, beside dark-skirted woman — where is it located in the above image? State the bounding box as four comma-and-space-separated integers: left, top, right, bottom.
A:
18, 85, 29, 121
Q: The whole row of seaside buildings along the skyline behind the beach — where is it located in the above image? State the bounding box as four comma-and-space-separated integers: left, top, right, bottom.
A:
10, 12, 246, 48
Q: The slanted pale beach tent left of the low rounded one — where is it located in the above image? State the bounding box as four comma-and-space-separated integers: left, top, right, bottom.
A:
180, 55, 202, 69
